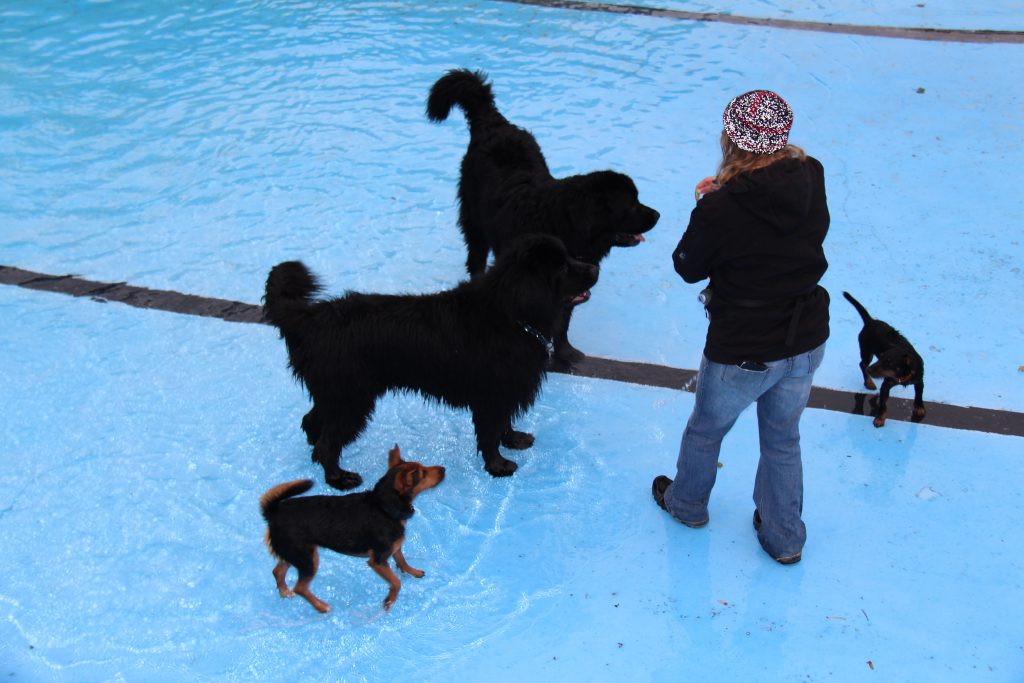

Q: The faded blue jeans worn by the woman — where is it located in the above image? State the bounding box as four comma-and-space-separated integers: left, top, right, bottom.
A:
665, 344, 825, 558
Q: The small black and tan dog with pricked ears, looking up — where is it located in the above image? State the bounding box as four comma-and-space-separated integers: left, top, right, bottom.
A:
260, 443, 444, 612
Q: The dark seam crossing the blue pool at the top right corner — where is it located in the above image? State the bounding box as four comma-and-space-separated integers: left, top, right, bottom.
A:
497, 0, 1024, 43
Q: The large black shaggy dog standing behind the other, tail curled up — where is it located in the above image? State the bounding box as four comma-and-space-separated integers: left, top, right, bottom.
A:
427, 69, 659, 364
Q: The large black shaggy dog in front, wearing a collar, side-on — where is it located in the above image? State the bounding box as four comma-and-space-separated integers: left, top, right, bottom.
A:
264, 236, 598, 489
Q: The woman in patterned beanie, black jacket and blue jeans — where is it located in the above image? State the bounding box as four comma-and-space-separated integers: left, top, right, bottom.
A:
651, 90, 828, 564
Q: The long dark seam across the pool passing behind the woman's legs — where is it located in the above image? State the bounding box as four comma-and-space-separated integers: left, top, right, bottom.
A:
0, 265, 1024, 436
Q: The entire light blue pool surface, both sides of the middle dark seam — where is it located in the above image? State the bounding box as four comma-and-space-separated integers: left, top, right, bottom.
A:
0, 2, 1024, 681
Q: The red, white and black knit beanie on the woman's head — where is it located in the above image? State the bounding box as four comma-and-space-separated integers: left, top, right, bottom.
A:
722, 90, 793, 155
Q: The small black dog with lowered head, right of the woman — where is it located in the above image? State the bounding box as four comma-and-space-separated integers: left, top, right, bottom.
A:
843, 292, 925, 427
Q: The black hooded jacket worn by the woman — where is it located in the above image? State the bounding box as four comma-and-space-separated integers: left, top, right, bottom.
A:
672, 157, 828, 364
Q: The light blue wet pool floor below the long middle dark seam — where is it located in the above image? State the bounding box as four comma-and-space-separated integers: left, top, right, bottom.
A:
0, 288, 1024, 681
